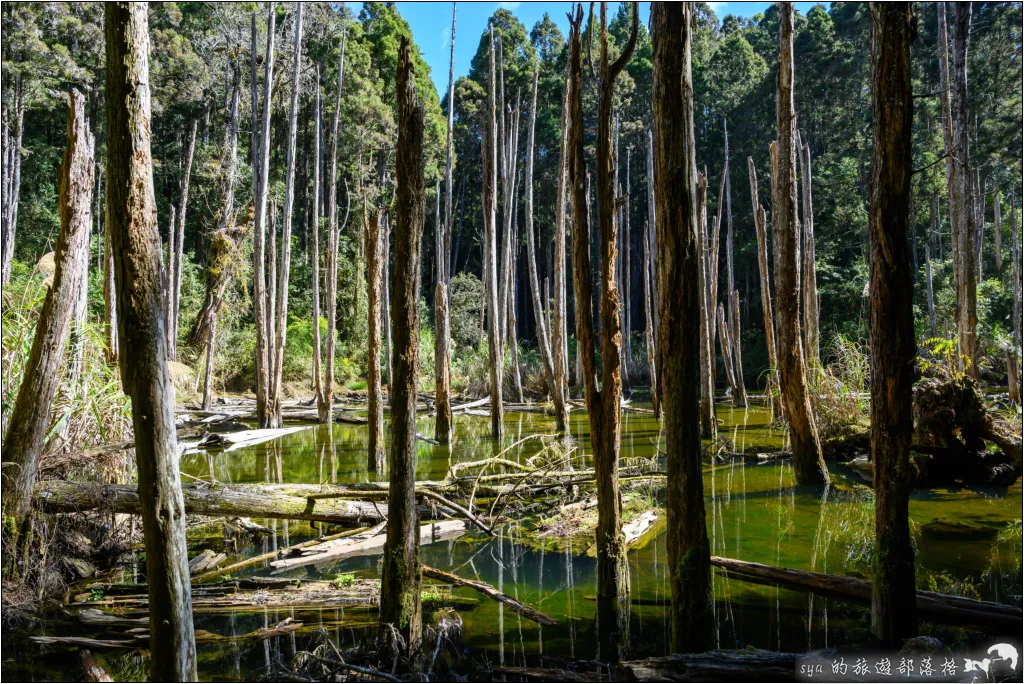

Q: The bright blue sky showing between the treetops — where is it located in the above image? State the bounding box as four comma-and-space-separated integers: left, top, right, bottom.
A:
364, 2, 816, 98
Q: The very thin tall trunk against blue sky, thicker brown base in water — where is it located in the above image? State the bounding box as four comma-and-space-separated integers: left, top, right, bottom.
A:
434, 3, 456, 444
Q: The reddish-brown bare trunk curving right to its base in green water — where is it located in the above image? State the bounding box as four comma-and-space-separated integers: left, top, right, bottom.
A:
772, 2, 828, 484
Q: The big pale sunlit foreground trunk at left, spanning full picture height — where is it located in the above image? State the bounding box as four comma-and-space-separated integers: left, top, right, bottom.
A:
104, 3, 197, 682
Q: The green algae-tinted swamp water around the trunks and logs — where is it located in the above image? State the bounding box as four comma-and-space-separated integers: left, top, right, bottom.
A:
3, 407, 1022, 680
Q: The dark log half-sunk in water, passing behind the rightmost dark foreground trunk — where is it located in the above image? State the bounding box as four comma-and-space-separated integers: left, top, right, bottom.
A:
711, 556, 1024, 634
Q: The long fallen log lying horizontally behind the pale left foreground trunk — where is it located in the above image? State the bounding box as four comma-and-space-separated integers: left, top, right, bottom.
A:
34, 480, 387, 525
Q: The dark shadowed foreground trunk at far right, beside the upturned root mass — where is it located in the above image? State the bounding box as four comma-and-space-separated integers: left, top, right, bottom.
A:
868, 3, 918, 643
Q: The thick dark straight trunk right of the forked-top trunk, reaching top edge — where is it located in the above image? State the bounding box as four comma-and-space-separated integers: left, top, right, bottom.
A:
651, 2, 712, 652
